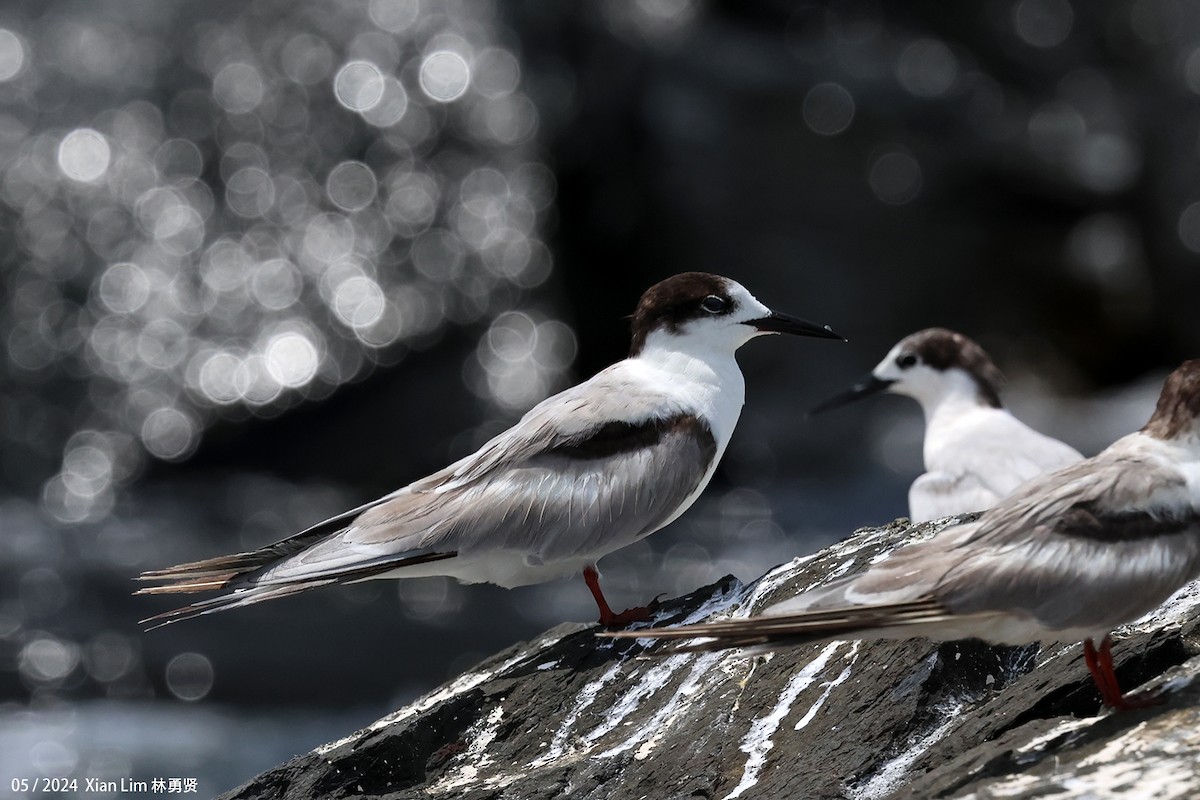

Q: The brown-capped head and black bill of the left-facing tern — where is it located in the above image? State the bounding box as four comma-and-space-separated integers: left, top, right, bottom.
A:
812, 327, 1003, 414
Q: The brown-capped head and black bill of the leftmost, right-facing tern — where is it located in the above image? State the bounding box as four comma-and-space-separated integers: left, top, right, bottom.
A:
629, 272, 842, 356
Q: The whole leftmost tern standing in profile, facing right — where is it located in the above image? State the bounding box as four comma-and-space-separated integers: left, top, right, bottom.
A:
139, 272, 842, 626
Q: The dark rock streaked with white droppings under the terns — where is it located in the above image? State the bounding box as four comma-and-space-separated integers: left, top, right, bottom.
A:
218, 521, 1200, 800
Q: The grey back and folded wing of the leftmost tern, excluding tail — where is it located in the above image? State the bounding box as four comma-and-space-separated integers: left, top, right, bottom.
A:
247, 365, 716, 584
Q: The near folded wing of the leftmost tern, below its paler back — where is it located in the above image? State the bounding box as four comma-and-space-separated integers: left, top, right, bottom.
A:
254, 417, 715, 584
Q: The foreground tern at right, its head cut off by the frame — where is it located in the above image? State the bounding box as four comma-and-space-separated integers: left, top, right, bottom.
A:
617, 361, 1200, 709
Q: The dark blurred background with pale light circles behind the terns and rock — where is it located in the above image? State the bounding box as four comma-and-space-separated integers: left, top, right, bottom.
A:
0, 0, 1200, 795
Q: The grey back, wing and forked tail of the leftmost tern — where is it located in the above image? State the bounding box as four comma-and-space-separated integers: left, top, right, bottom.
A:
138, 362, 718, 625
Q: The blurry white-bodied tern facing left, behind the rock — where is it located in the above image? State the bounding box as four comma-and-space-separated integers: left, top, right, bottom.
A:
812, 327, 1084, 522
